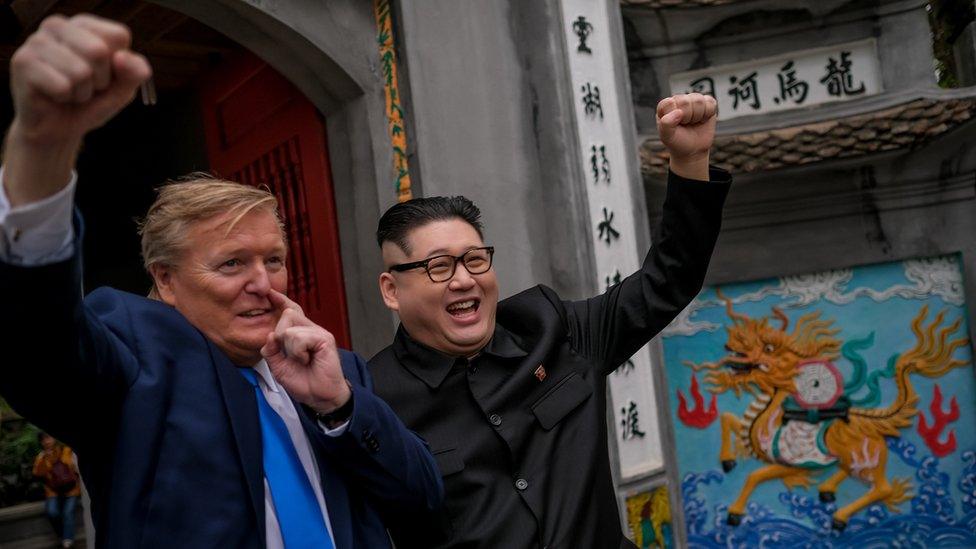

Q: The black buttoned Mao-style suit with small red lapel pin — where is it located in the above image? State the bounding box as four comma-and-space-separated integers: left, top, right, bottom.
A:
370, 170, 731, 549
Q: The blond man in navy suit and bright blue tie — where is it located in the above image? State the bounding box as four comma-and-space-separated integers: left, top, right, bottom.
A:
0, 15, 442, 549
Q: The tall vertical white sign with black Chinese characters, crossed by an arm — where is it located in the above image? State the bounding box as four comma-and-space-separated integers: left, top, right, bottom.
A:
563, 0, 664, 480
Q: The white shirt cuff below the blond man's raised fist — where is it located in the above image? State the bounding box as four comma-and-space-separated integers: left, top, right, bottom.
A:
0, 168, 78, 267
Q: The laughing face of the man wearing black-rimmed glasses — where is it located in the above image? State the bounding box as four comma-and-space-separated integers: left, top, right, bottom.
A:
380, 218, 498, 356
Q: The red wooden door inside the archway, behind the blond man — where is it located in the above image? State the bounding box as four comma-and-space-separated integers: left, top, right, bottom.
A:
200, 54, 350, 348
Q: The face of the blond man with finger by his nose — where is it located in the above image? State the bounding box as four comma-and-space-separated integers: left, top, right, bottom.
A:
151, 208, 288, 365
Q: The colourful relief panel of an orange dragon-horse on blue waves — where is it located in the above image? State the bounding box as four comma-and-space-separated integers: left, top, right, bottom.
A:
664, 256, 976, 547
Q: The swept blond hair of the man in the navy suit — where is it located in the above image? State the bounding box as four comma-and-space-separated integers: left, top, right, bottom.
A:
139, 173, 285, 297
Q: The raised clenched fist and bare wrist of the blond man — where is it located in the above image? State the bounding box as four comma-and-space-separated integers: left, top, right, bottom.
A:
4, 14, 152, 206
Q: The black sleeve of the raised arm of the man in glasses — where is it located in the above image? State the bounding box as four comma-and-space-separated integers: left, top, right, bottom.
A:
563, 168, 732, 375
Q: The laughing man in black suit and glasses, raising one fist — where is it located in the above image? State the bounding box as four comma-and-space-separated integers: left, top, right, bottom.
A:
370, 94, 731, 549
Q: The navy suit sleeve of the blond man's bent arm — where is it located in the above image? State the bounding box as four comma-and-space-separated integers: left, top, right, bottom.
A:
310, 351, 444, 512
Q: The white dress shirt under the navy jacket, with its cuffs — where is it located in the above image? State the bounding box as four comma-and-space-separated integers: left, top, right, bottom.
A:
0, 167, 349, 549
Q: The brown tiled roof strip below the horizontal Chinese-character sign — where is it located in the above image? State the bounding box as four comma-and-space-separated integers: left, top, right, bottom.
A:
640, 98, 976, 176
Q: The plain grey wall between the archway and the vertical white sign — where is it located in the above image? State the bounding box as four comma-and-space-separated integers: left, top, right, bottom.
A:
399, 0, 592, 302
